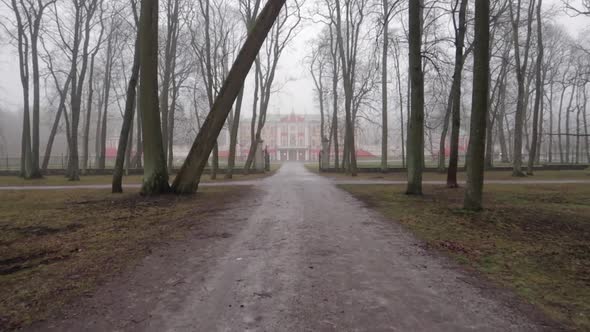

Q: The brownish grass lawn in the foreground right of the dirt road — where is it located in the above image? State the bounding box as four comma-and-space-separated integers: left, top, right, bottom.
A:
342, 184, 590, 331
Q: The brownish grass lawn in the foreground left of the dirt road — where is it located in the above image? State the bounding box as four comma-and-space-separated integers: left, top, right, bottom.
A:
0, 187, 250, 330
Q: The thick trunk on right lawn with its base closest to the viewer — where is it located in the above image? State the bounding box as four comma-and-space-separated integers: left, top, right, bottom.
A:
463, 0, 490, 210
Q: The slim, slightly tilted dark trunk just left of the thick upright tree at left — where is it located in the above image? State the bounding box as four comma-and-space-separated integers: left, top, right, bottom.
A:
112, 31, 139, 193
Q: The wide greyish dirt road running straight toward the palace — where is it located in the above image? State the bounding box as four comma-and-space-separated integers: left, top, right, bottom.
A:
34, 164, 548, 331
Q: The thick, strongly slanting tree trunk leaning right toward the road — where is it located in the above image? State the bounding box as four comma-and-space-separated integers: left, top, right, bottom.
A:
172, 0, 286, 194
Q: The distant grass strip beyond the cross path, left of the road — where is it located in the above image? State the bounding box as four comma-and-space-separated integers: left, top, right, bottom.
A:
0, 164, 281, 187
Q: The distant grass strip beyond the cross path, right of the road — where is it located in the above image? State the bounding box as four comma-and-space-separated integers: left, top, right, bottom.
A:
320, 166, 590, 181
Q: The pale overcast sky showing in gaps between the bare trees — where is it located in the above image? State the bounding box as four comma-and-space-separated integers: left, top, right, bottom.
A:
0, 0, 590, 118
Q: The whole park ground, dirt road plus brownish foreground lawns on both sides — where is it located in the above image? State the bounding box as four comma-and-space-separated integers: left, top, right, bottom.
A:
0, 163, 590, 332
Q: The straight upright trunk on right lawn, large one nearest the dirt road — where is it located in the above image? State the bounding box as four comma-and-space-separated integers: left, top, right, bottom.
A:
406, 1, 424, 195
